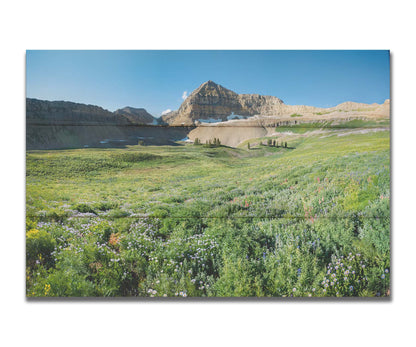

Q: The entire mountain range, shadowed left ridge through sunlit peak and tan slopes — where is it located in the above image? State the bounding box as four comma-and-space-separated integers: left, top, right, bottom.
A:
26, 81, 390, 149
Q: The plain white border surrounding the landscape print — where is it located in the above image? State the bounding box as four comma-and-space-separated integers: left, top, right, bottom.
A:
0, 0, 416, 346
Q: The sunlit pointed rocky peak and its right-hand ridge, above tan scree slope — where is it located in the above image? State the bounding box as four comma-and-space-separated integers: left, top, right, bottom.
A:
162, 81, 389, 126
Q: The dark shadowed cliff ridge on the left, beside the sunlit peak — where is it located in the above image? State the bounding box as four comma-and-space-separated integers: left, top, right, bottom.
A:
26, 98, 192, 150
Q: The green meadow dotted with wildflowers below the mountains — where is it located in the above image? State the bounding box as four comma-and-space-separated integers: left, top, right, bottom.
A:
26, 131, 390, 297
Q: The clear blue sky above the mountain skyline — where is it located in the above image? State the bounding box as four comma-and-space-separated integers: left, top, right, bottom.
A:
26, 50, 390, 116
